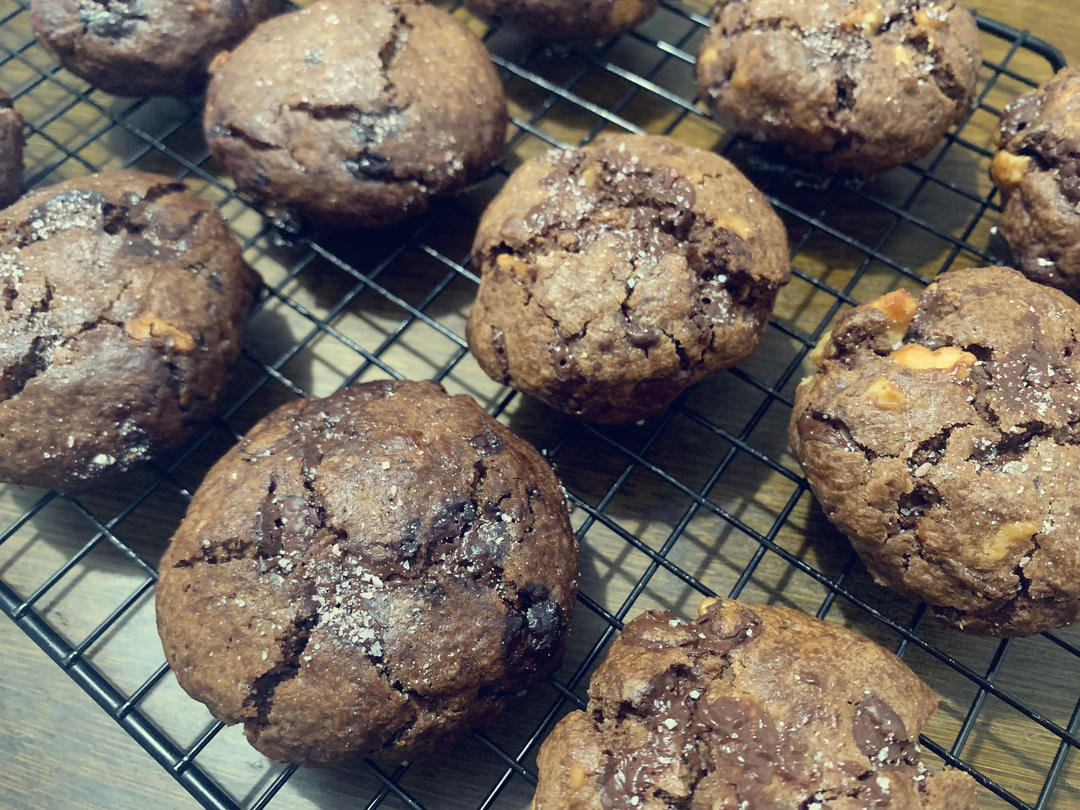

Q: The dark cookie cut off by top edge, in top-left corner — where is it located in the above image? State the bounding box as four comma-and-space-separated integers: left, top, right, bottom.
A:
30, 0, 284, 96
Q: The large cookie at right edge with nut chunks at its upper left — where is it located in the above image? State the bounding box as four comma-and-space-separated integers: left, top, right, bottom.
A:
788, 268, 1080, 636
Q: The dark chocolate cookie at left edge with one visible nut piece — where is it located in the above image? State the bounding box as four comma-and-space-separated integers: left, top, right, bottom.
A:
0, 171, 258, 490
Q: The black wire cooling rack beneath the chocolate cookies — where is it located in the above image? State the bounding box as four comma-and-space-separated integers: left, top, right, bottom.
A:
0, 0, 1080, 809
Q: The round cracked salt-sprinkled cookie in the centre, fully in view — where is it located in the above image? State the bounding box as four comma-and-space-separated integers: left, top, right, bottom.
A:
467, 135, 789, 422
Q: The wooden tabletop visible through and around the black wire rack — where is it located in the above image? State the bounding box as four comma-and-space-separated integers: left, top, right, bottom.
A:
0, 0, 1080, 810
